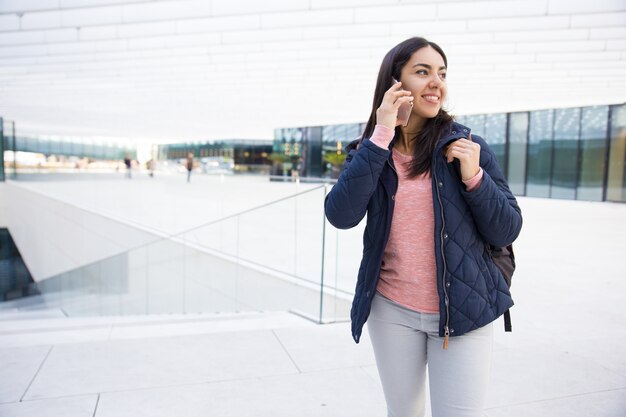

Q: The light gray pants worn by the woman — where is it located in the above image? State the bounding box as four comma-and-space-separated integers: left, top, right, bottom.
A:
368, 293, 493, 417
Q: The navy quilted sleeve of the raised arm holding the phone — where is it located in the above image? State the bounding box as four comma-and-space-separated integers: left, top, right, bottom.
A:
324, 139, 390, 229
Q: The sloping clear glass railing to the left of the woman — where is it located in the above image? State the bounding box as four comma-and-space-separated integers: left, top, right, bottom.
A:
34, 181, 360, 323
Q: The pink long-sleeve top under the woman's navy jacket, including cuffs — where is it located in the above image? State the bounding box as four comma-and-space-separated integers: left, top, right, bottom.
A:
371, 125, 483, 313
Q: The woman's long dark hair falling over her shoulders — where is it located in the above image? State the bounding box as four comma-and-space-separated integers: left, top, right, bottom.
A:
361, 37, 453, 178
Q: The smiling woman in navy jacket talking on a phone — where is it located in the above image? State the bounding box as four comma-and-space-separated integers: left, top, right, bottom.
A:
325, 38, 522, 417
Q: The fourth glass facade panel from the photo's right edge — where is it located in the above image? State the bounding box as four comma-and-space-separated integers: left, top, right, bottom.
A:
526, 110, 554, 197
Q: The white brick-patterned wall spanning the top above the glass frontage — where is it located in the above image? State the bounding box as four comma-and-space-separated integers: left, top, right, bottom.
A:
0, 0, 626, 137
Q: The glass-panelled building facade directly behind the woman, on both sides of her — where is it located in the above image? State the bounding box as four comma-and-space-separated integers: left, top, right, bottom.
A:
273, 104, 626, 202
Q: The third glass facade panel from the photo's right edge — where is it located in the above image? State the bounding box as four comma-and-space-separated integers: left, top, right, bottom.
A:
550, 108, 581, 199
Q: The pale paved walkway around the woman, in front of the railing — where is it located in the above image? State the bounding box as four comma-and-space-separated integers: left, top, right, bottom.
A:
0, 173, 626, 417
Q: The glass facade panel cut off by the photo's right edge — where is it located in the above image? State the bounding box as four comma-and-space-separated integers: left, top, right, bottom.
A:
606, 104, 626, 202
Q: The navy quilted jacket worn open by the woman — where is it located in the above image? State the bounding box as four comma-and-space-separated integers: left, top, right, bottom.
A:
325, 123, 522, 343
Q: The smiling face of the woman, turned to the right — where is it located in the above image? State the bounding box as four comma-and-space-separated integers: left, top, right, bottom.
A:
400, 46, 448, 119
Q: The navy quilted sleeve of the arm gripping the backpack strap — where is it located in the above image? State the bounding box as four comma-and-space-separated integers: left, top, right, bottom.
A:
462, 136, 522, 247
